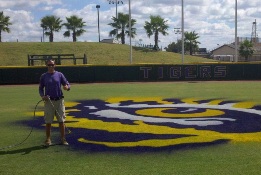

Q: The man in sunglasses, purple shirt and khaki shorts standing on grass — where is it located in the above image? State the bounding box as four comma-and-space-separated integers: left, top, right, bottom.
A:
39, 60, 70, 146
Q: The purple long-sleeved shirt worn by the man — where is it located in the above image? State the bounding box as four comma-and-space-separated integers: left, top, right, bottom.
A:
39, 71, 70, 98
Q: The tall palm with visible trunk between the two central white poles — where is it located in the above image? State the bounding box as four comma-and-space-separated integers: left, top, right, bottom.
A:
144, 15, 169, 50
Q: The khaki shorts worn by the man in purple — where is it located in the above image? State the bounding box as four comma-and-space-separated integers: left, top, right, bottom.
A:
44, 99, 66, 124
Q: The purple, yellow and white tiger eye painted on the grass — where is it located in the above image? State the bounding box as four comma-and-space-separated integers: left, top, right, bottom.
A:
34, 98, 261, 150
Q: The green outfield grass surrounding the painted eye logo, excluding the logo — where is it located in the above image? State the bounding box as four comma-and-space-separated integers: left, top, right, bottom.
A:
0, 81, 261, 175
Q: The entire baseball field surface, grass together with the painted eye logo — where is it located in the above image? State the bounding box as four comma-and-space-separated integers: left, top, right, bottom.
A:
0, 81, 261, 175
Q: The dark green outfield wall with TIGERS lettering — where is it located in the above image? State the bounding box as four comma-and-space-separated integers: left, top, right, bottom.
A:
0, 63, 261, 85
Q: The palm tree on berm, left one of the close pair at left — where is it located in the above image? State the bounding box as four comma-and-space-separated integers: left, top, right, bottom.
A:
41, 15, 62, 42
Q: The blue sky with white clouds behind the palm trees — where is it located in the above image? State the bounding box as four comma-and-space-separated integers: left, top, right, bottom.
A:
0, 0, 261, 50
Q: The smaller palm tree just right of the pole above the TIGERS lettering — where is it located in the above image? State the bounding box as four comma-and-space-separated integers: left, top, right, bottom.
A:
184, 31, 200, 55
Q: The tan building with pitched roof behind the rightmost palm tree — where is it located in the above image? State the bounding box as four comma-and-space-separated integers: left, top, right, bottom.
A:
211, 38, 261, 62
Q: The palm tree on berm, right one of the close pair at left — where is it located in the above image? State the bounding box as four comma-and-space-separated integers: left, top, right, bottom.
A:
63, 15, 86, 42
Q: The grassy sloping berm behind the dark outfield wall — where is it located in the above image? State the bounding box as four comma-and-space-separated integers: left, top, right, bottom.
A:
0, 42, 214, 66
